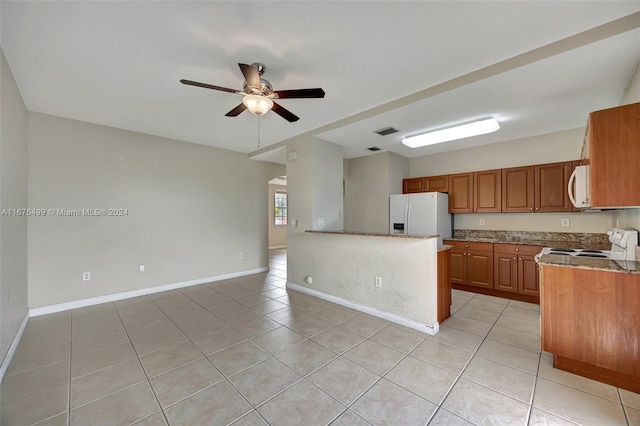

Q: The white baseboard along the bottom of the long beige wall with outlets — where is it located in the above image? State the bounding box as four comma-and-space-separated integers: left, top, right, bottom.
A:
29, 267, 269, 317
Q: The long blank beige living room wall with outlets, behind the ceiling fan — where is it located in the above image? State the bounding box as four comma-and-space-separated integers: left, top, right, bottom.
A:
28, 113, 284, 308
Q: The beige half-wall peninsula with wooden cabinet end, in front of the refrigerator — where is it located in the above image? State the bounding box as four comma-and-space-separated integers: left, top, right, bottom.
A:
287, 231, 451, 334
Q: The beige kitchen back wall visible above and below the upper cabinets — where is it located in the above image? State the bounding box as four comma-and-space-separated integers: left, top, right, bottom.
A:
409, 131, 612, 233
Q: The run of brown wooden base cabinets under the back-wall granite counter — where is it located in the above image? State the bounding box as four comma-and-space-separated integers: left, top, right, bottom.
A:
444, 240, 542, 303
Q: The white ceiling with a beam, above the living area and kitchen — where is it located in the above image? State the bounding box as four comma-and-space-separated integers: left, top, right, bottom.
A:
0, 0, 640, 161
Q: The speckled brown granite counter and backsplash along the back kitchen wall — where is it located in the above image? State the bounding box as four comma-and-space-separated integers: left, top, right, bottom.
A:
453, 229, 611, 250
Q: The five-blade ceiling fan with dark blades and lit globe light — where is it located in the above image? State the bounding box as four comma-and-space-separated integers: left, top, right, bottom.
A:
180, 62, 324, 122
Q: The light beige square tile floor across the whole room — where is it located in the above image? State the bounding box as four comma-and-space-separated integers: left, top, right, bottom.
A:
0, 250, 640, 426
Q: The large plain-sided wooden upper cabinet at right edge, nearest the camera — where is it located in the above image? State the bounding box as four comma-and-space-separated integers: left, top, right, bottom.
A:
585, 102, 640, 207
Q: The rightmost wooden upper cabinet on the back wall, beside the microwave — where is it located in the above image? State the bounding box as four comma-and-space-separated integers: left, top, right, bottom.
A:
534, 161, 573, 213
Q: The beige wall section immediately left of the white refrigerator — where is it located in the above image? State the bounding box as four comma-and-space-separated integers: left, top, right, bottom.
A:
344, 152, 409, 233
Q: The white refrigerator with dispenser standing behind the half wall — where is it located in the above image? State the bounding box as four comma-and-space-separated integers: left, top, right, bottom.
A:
389, 192, 451, 244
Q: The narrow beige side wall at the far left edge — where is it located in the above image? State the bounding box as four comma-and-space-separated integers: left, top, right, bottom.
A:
0, 50, 28, 366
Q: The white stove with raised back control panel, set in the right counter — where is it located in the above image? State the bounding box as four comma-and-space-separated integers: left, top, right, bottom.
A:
536, 228, 638, 261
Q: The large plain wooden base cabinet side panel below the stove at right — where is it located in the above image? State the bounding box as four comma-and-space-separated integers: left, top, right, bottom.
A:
540, 265, 640, 393
